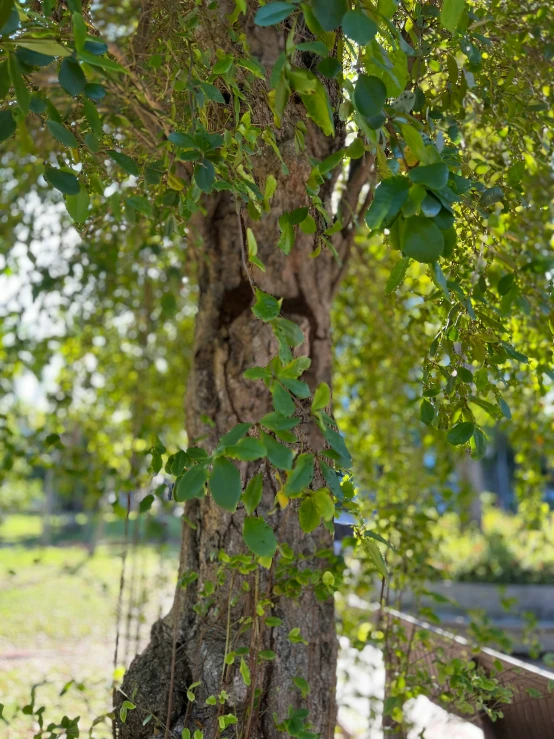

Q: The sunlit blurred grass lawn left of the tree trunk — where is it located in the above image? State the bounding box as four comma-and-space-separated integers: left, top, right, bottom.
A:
0, 532, 177, 739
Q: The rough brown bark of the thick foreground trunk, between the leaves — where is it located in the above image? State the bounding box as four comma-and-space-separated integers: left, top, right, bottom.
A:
118, 3, 361, 739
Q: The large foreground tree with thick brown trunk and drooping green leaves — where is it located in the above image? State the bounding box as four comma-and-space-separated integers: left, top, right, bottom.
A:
0, 0, 552, 739
